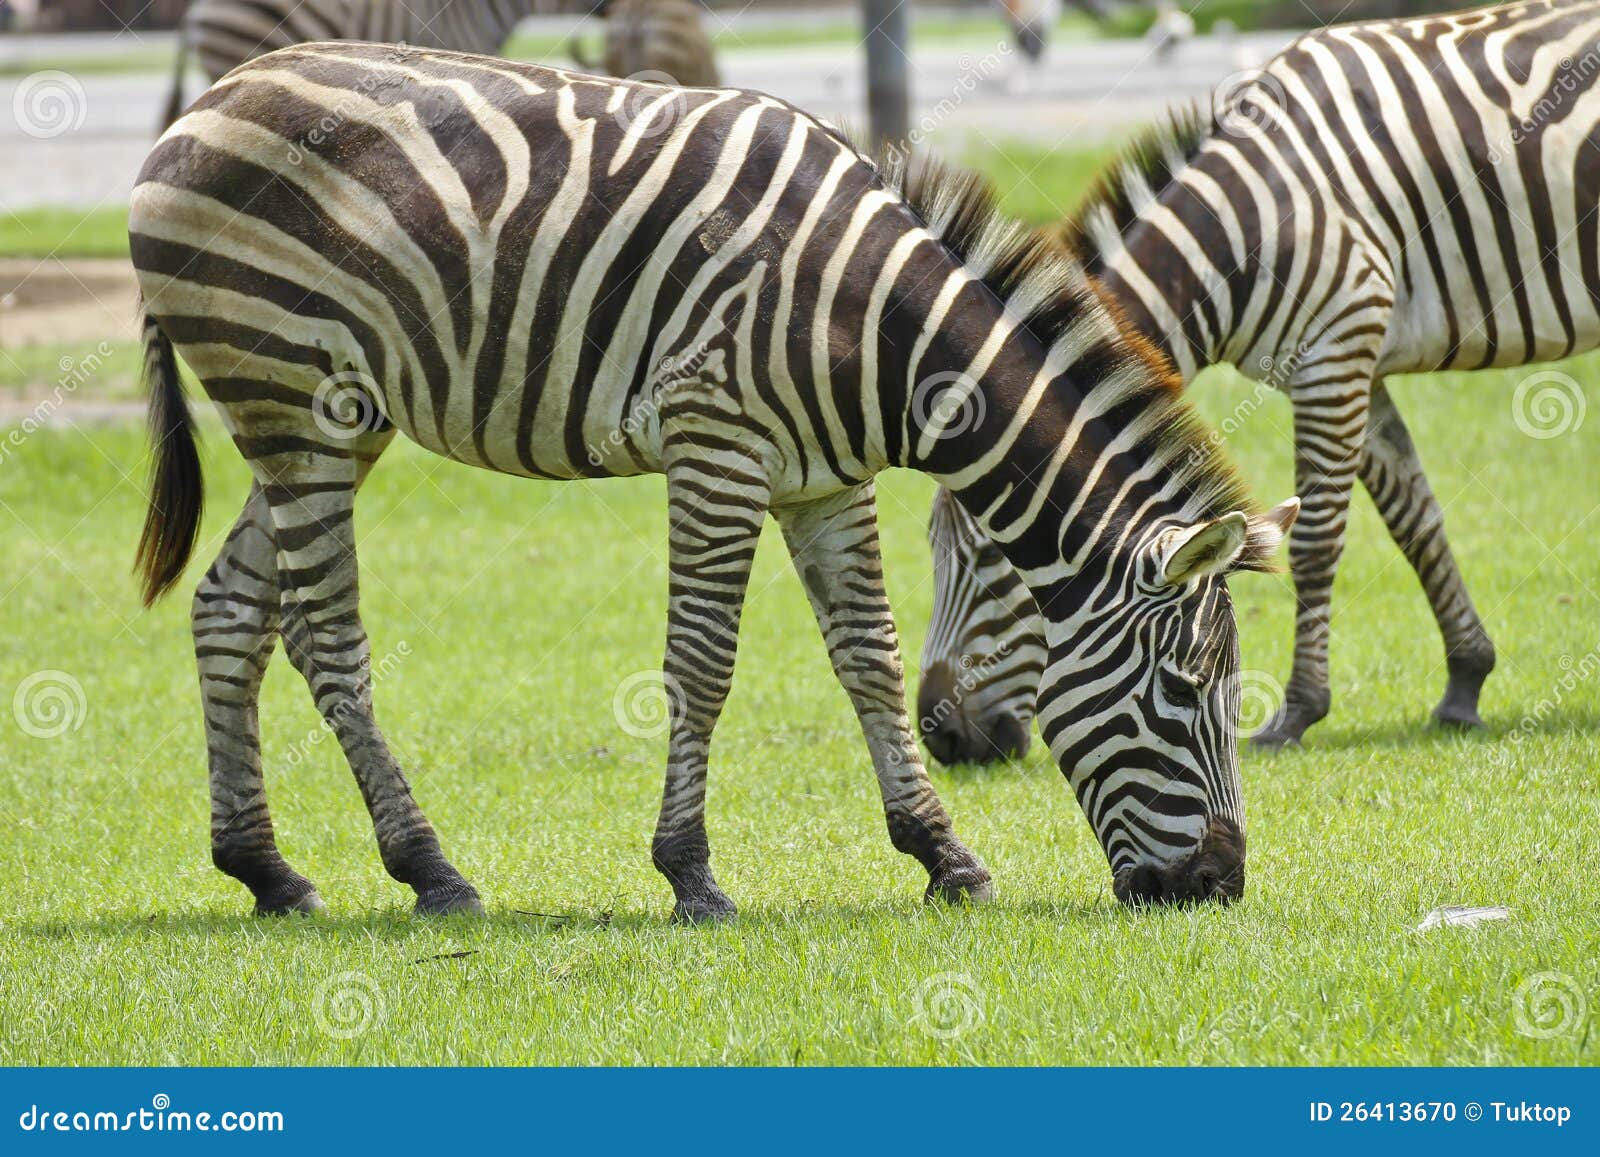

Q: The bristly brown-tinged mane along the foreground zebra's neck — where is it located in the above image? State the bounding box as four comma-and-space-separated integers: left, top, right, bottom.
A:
877, 140, 1256, 520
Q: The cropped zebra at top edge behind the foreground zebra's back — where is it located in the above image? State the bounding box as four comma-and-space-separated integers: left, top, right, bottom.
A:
162, 0, 576, 128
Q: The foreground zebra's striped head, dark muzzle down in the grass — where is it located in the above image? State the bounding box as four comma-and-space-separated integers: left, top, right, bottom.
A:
1032, 498, 1299, 904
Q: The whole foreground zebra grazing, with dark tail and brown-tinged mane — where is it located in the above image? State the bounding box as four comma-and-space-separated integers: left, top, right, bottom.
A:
128, 43, 1296, 920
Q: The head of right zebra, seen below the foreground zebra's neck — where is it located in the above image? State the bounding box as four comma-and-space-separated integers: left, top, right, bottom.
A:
917, 488, 1045, 763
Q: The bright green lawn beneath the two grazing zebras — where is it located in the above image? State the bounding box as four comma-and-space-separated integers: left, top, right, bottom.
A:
0, 360, 1600, 1064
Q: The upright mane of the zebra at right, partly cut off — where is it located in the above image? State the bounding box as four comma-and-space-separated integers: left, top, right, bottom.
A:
1050, 104, 1216, 274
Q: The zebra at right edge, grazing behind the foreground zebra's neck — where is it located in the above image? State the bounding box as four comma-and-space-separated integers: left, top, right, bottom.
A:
920, 0, 1600, 759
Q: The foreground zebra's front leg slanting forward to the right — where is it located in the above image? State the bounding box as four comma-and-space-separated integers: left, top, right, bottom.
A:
776, 482, 992, 903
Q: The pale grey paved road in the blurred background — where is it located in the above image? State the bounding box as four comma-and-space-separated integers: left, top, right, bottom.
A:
0, 24, 1288, 210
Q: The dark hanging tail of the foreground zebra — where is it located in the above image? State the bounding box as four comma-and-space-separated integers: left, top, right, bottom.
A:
133, 304, 205, 607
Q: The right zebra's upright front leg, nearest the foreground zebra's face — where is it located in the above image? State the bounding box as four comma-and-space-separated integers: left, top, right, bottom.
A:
1251, 364, 1376, 747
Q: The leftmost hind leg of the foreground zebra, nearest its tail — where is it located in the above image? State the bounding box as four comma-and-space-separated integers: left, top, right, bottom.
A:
190, 486, 323, 915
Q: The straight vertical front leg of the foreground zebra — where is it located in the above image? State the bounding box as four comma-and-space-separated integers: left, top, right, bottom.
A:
651, 432, 768, 922
